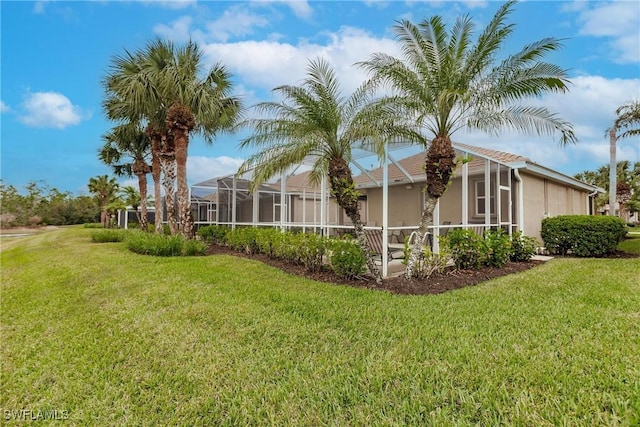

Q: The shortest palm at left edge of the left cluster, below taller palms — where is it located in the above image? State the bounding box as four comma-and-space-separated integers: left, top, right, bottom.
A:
98, 123, 151, 231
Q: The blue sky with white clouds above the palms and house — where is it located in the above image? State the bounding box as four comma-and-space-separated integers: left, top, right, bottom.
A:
0, 0, 640, 194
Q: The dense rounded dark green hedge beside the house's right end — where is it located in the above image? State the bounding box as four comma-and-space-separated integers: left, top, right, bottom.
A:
540, 215, 627, 257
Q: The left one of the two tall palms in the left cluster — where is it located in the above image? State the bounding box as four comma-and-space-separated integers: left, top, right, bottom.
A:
103, 39, 178, 234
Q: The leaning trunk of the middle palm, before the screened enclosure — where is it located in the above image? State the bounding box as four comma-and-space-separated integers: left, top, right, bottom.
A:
329, 158, 386, 285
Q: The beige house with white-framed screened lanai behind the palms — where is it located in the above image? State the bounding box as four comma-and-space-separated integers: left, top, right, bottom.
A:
186, 143, 597, 276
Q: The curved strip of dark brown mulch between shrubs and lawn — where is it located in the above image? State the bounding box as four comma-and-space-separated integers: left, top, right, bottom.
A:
208, 245, 542, 295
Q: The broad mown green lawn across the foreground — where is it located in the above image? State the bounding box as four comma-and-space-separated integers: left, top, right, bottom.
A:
0, 228, 640, 426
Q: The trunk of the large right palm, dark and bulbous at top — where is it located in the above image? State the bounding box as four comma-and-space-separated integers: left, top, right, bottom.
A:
404, 135, 456, 280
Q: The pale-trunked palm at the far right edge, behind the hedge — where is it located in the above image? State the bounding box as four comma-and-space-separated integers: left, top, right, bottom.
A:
609, 101, 640, 215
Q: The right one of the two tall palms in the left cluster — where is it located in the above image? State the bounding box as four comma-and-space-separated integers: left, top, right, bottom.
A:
160, 41, 240, 237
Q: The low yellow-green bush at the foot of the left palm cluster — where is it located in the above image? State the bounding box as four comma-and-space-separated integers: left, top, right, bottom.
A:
126, 231, 207, 256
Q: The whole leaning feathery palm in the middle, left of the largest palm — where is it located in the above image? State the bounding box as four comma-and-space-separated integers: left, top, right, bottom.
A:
239, 59, 412, 283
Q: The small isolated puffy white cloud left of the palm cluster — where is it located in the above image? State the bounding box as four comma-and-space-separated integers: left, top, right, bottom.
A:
19, 92, 83, 129
